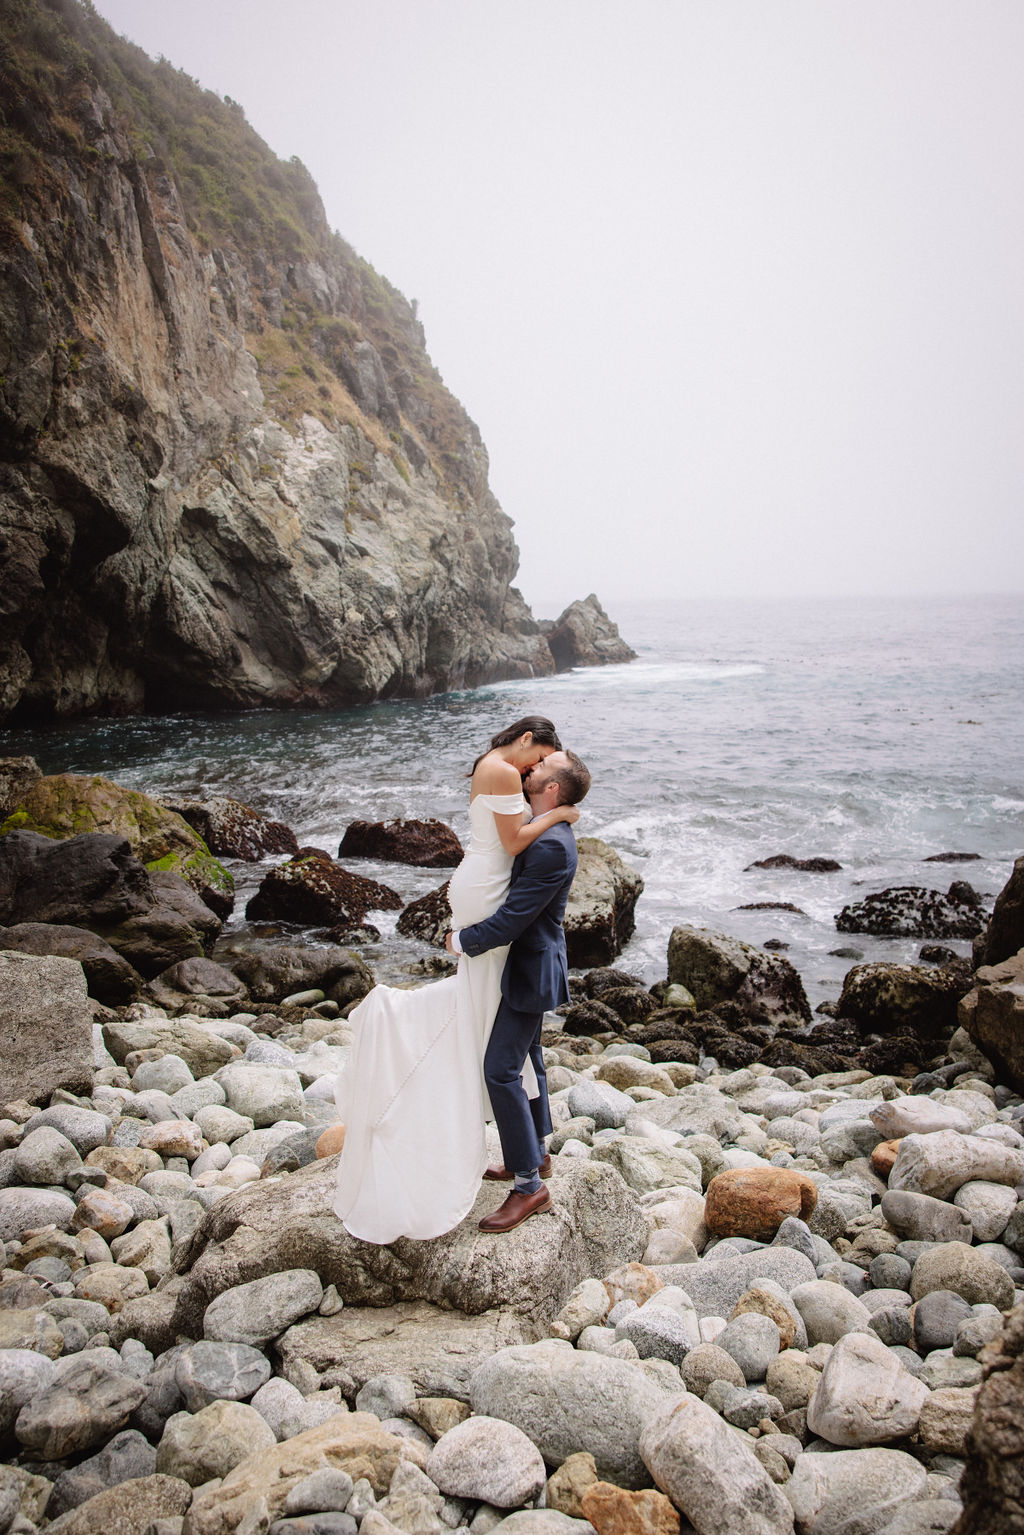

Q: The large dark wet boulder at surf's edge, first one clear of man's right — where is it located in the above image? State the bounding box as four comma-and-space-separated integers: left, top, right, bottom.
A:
668, 926, 811, 1027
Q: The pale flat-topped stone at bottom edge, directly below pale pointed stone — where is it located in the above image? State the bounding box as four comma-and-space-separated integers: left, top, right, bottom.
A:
786, 1449, 927, 1535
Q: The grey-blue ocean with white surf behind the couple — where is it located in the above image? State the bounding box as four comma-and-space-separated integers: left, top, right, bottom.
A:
0, 596, 1024, 1005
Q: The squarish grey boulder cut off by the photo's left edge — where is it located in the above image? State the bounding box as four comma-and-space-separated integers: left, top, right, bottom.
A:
0, 950, 92, 1104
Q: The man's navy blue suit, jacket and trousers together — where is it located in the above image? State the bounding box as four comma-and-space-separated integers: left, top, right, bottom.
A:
459, 821, 576, 1173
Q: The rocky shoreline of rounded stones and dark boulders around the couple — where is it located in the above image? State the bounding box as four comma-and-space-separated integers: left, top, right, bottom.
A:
0, 763, 1024, 1535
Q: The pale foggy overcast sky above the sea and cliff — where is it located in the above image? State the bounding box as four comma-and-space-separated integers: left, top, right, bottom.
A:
97, 0, 1024, 614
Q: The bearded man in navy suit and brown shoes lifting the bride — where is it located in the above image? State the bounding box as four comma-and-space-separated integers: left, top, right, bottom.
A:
445, 752, 590, 1231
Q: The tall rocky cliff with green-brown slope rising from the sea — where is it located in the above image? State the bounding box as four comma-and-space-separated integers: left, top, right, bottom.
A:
0, 0, 631, 723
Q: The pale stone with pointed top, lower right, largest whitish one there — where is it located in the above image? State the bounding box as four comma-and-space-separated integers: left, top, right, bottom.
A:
808, 1332, 929, 1449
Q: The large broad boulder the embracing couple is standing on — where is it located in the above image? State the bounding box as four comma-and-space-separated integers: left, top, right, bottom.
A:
175, 1157, 648, 1337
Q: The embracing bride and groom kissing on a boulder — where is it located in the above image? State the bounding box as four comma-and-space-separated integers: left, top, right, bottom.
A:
335, 715, 590, 1243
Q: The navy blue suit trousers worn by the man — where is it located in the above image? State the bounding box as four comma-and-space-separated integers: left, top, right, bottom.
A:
484, 998, 551, 1173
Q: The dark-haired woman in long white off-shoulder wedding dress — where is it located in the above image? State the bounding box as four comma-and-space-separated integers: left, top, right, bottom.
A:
335, 715, 579, 1243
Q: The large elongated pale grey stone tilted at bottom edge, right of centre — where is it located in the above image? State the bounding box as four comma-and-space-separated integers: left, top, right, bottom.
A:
640, 1395, 792, 1535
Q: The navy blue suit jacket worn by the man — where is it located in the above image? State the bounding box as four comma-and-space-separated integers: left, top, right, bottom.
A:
459, 821, 576, 1013
